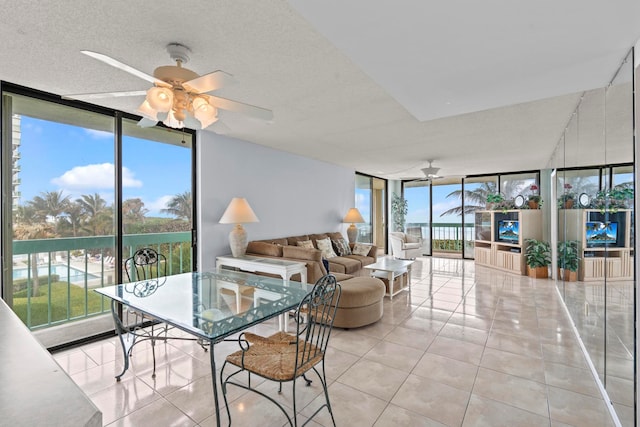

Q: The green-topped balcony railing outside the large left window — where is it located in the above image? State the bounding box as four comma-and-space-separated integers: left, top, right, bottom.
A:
12, 232, 191, 330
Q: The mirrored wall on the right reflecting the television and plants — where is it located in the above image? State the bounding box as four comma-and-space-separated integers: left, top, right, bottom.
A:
550, 48, 636, 426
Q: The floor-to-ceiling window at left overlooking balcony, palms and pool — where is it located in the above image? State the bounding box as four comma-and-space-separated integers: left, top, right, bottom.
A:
2, 84, 193, 352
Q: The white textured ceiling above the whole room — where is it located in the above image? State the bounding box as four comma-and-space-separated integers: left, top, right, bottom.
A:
0, 0, 640, 178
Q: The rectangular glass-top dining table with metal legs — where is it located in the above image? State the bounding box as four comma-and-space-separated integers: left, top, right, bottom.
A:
95, 270, 312, 426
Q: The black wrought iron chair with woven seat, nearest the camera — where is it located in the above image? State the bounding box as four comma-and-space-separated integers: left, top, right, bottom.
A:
220, 275, 340, 426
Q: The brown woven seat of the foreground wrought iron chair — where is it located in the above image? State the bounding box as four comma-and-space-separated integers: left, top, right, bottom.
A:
227, 332, 324, 381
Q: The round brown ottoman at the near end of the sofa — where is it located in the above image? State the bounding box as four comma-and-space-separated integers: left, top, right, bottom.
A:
333, 277, 386, 328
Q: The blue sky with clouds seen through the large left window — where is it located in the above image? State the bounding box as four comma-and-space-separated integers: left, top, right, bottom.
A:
19, 116, 191, 216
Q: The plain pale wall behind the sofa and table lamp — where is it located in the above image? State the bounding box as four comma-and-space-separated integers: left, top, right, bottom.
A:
197, 132, 355, 271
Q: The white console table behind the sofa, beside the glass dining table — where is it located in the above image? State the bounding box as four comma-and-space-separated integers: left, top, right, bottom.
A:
216, 255, 307, 332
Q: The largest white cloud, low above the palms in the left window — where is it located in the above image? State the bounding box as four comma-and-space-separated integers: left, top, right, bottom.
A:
51, 163, 142, 189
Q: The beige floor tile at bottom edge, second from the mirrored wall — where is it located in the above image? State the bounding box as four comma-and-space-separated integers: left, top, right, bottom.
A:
462, 394, 549, 427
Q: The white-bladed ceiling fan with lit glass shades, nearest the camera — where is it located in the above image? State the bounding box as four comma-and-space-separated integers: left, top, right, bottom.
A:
64, 43, 273, 129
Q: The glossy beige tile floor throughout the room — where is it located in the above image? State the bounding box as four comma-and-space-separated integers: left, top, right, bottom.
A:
54, 258, 614, 427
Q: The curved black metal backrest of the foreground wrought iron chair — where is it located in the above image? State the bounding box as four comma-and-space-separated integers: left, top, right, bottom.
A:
296, 274, 341, 376
